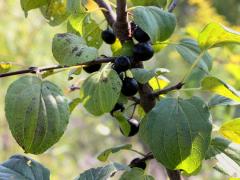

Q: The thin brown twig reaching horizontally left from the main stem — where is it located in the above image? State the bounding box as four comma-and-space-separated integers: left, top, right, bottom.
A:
0, 57, 116, 78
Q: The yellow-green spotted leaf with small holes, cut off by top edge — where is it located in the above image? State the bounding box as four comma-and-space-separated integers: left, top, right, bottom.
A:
40, 0, 69, 26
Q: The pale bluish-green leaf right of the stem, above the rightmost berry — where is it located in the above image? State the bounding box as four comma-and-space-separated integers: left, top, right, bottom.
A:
132, 6, 176, 44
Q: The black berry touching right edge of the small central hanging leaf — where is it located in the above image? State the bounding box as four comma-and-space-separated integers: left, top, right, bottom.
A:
122, 77, 138, 96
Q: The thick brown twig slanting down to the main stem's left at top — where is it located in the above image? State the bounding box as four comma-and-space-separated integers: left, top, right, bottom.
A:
94, 0, 116, 26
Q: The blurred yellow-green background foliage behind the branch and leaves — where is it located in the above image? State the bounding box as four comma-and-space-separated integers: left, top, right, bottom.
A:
0, 0, 240, 180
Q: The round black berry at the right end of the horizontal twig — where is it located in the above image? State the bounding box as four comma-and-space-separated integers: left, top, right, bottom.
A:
114, 56, 131, 72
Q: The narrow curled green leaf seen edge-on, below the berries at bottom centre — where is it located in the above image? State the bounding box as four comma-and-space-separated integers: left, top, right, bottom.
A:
97, 144, 132, 162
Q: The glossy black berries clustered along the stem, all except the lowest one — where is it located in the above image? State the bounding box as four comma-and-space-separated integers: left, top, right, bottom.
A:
83, 23, 154, 136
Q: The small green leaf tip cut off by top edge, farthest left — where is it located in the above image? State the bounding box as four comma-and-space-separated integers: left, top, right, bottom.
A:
21, 0, 48, 15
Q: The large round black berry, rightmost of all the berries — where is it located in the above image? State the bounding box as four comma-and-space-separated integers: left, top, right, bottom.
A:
133, 43, 154, 61
